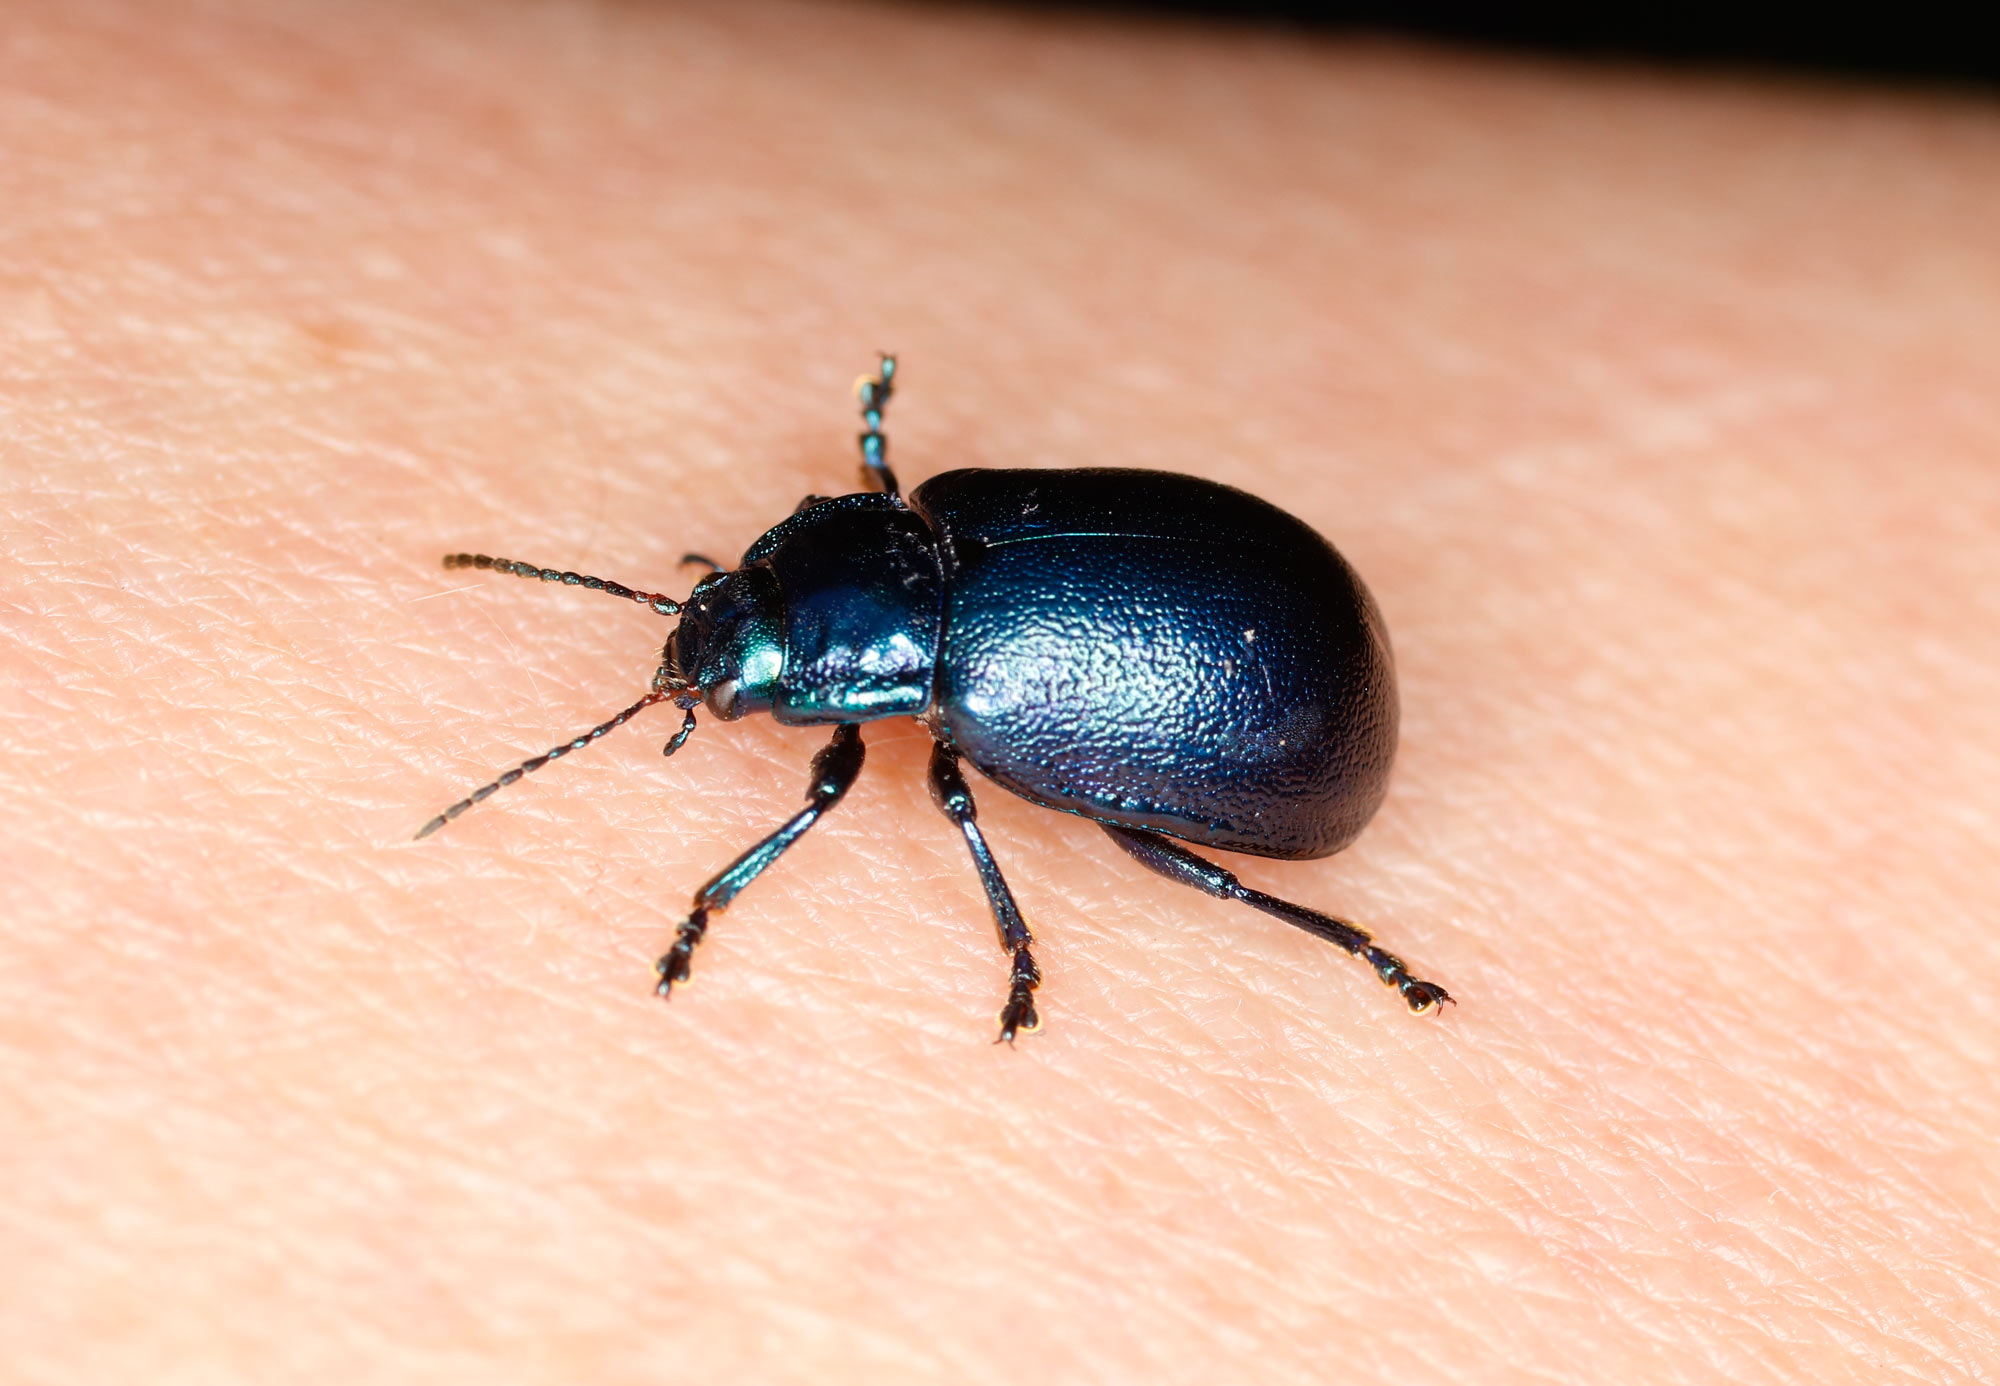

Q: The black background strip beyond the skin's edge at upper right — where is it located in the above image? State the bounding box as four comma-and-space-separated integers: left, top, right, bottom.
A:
1028, 0, 2000, 88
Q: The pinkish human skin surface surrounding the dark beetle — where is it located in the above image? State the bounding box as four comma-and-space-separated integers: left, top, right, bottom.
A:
0, 0, 2000, 1384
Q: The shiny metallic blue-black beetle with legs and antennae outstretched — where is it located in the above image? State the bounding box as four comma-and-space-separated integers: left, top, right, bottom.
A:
416, 354, 1452, 1042
